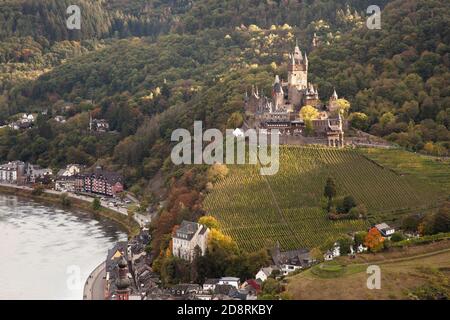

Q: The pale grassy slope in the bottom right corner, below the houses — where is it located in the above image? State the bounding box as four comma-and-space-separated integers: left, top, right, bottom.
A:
286, 243, 450, 300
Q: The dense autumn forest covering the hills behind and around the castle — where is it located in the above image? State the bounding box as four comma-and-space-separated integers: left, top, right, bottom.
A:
0, 0, 450, 280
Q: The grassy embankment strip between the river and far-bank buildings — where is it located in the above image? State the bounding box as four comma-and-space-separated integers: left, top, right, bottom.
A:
0, 184, 140, 237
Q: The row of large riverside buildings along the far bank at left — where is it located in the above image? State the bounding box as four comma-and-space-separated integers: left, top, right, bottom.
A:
0, 161, 124, 197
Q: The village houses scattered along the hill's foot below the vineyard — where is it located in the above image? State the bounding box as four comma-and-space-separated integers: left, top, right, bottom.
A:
105, 215, 395, 300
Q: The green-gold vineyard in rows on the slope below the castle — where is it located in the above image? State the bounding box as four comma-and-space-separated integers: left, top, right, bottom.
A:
204, 147, 446, 250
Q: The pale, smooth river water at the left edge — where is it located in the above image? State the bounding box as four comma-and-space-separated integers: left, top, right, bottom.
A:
0, 194, 126, 299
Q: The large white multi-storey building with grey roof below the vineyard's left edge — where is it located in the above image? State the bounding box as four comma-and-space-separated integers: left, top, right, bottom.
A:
172, 221, 209, 261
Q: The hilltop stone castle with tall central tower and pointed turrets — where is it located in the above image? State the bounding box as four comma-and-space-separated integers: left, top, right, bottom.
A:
245, 44, 347, 147
